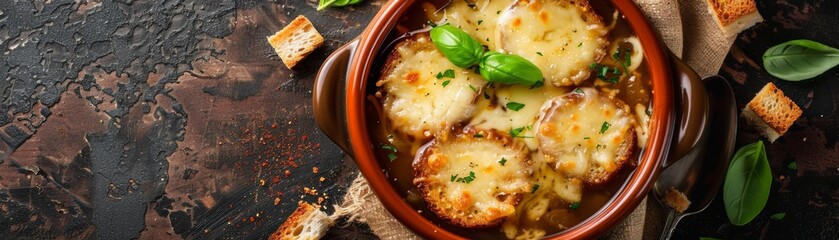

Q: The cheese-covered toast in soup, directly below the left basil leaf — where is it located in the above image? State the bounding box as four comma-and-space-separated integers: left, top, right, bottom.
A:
377, 34, 486, 139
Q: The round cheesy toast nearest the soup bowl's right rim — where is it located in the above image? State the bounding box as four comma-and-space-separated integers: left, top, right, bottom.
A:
537, 88, 635, 183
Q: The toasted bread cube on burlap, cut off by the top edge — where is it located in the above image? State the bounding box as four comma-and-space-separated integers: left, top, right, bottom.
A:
708, 0, 763, 37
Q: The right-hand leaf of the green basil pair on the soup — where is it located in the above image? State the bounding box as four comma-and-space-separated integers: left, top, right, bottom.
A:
480, 52, 543, 86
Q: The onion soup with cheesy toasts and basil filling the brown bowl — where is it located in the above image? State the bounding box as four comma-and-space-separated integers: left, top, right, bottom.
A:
366, 0, 652, 239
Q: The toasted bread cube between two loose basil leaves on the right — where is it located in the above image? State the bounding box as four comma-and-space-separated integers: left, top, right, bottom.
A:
743, 83, 802, 142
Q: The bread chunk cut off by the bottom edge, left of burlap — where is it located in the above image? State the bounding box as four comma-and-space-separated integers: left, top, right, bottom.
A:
268, 202, 332, 240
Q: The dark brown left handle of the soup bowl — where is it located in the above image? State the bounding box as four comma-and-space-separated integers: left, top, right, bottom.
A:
312, 39, 358, 156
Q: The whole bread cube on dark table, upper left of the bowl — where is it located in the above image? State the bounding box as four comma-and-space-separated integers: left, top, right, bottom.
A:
268, 15, 323, 69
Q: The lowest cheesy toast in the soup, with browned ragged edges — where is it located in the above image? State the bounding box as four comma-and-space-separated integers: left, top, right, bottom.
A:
414, 131, 532, 226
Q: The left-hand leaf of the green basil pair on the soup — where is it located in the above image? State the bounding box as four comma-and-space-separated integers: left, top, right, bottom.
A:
430, 25, 484, 68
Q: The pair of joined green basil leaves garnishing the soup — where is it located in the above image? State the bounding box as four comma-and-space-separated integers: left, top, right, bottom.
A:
430, 24, 544, 86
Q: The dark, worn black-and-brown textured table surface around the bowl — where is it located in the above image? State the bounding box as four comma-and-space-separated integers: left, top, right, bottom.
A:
0, 0, 839, 239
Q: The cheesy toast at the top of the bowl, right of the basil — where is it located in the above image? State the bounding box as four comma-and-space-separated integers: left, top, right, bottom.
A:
497, 0, 608, 86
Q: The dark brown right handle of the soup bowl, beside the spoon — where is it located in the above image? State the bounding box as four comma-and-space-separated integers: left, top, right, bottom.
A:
663, 53, 710, 167
